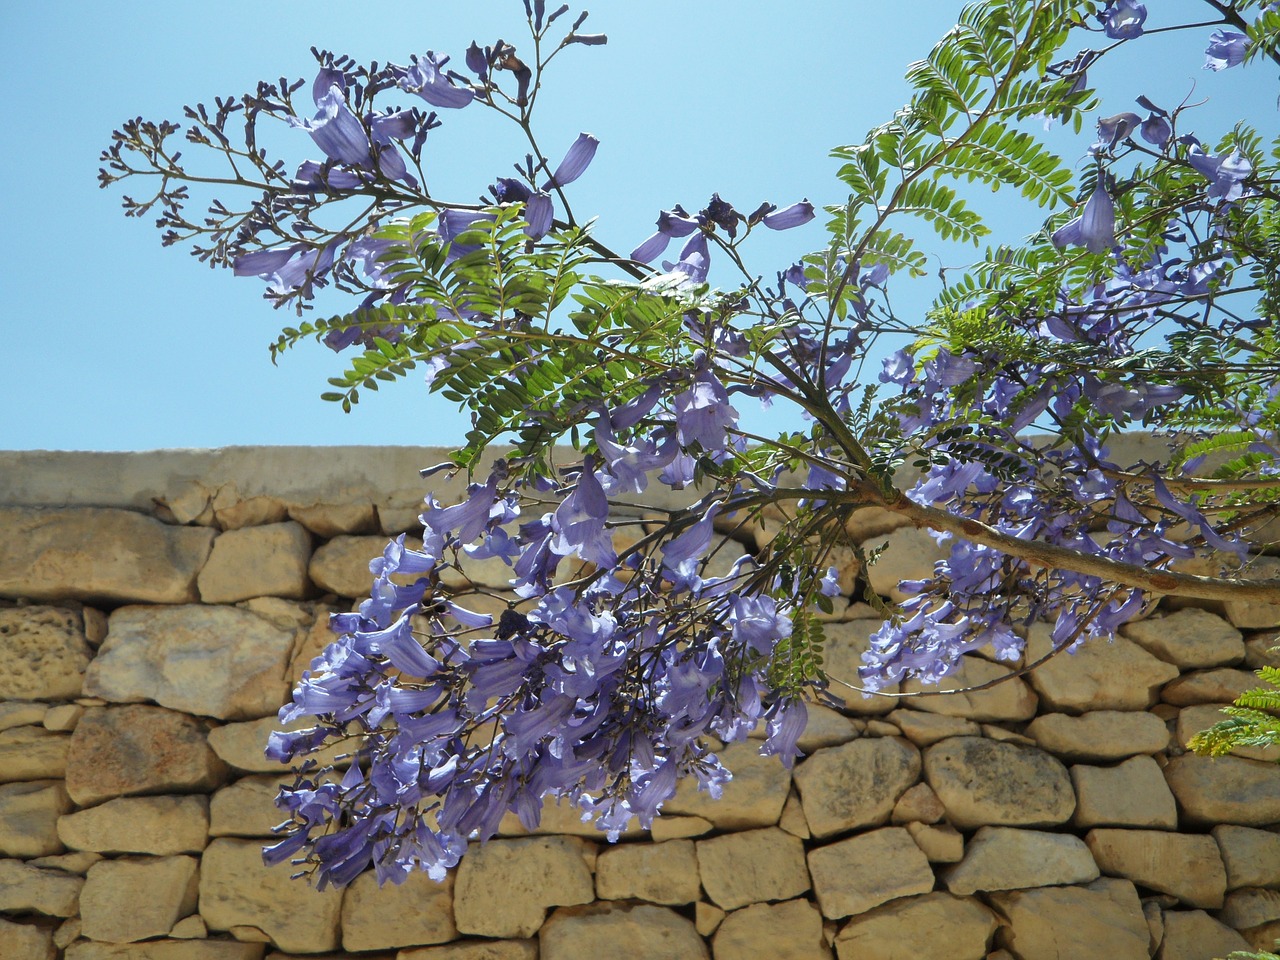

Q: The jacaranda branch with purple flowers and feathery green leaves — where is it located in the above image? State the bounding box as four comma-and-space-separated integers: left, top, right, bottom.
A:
101, 0, 1280, 886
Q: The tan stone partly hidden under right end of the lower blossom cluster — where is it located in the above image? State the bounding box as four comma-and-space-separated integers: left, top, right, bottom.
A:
662, 741, 791, 829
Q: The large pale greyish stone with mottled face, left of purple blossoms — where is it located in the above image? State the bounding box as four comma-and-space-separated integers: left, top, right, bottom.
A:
84, 604, 293, 719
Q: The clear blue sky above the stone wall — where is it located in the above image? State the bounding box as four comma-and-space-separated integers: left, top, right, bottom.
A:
0, 0, 1276, 451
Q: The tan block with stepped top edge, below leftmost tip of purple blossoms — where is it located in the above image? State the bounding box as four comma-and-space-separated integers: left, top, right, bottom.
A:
200, 838, 342, 954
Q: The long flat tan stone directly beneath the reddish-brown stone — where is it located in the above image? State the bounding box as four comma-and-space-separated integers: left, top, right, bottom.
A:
58, 796, 209, 856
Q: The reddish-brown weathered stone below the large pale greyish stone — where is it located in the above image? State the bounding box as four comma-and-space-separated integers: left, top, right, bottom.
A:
67, 705, 227, 806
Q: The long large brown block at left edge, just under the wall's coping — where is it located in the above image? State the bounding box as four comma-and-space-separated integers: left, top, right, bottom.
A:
0, 507, 214, 603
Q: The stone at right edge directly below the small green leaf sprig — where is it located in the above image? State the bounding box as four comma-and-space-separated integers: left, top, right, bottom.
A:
1165, 754, 1280, 827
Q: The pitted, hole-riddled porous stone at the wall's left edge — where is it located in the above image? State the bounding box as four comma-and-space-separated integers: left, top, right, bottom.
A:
0, 609, 93, 701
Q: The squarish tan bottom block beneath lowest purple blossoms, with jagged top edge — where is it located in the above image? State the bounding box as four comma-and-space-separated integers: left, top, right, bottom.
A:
342, 870, 458, 951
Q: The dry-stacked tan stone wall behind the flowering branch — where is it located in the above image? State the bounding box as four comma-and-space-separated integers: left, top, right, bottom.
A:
0, 448, 1280, 960
